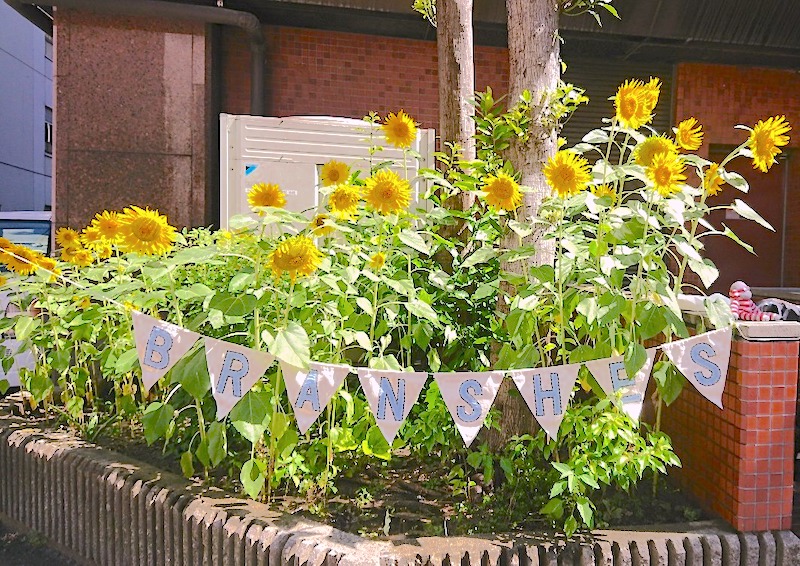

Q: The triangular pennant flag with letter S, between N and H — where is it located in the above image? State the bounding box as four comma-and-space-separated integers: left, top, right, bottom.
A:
433, 371, 504, 446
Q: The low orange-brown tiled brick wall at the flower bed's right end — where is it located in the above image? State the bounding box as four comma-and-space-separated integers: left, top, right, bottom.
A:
663, 323, 798, 531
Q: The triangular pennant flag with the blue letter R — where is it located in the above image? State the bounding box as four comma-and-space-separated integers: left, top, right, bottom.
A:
204, 337, 275, 421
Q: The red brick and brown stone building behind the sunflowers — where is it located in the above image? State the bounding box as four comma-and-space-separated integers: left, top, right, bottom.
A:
6, 0, 800, 286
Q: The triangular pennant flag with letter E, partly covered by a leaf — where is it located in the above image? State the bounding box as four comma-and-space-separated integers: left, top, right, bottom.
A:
584, 348, 656, 421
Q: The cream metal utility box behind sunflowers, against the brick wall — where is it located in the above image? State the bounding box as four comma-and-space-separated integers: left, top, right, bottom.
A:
220, 114, 435, 228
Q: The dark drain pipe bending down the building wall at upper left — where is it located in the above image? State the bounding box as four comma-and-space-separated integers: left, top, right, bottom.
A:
5, 0, 266, 116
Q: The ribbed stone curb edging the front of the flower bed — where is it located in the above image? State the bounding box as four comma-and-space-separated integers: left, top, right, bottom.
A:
0, 400, 800, 566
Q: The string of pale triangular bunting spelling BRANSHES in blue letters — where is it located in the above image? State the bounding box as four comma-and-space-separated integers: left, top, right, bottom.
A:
133, 311, 732, 446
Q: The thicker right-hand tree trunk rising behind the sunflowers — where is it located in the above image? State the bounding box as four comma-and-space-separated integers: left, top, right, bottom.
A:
488, 0, 561, 450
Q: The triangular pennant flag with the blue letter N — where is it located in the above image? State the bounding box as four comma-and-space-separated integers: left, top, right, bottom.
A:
358, 368, 428, 446
